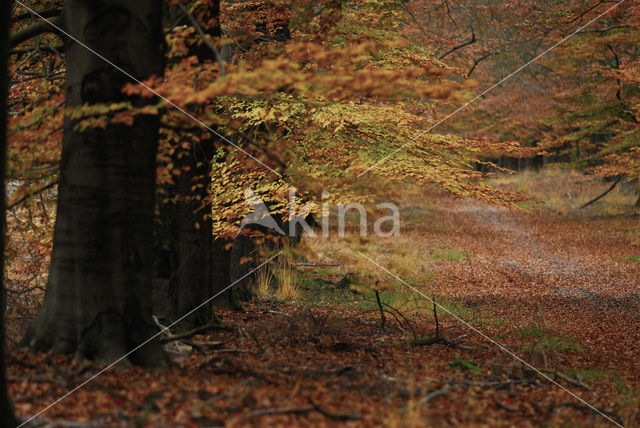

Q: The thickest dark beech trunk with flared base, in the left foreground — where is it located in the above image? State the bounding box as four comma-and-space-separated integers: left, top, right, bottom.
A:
23, 0, 168, 366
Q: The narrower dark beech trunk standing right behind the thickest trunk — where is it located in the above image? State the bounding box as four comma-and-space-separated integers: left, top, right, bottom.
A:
153, 0, 229, 328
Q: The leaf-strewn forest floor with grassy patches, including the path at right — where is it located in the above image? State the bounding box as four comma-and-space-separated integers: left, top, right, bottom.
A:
8, 169, 640, 427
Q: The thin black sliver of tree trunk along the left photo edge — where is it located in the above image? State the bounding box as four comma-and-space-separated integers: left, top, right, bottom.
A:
0, 1, 18, 428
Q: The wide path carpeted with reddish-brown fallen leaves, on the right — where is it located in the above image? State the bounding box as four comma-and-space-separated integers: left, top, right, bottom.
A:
428, 194, 640, 378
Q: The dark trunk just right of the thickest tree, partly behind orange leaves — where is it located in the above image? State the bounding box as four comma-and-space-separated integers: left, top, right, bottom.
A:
154, 0, 229, 329
